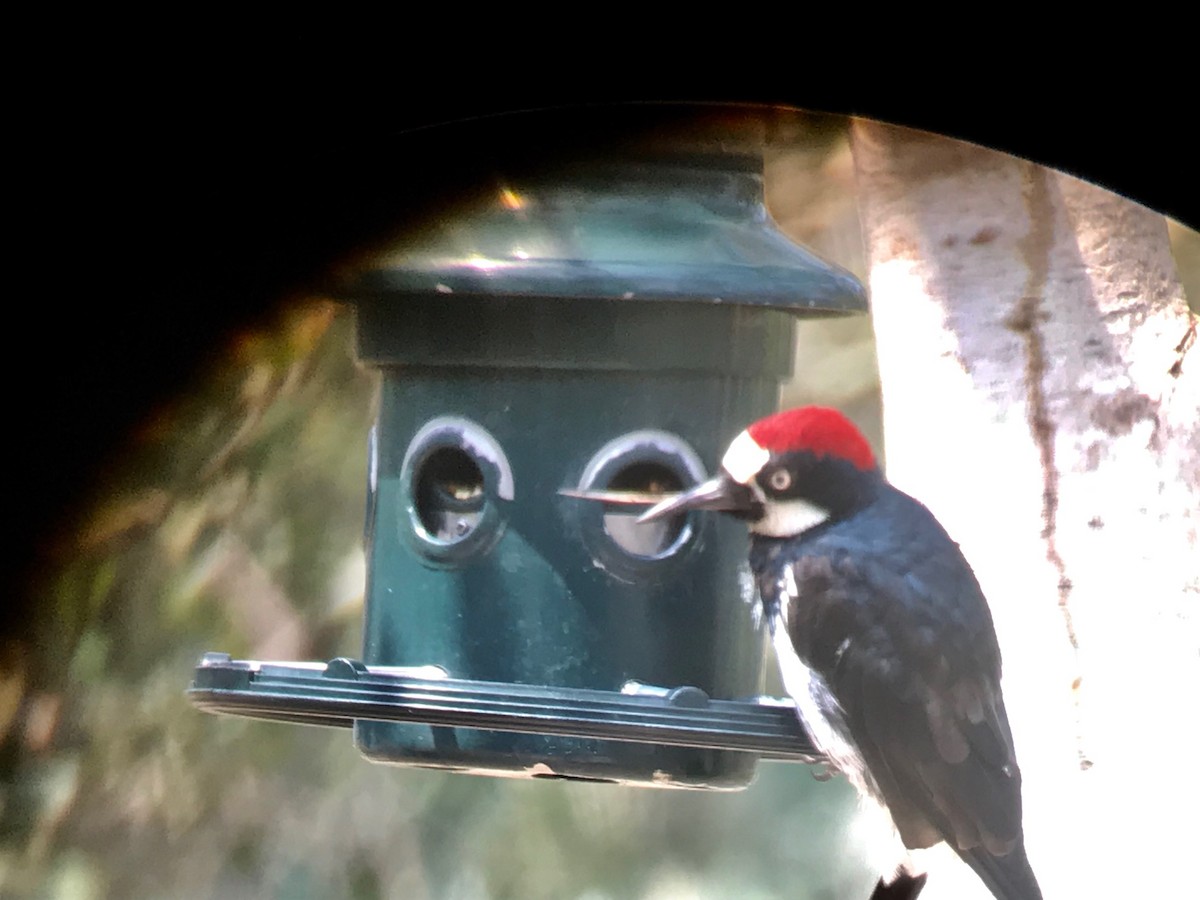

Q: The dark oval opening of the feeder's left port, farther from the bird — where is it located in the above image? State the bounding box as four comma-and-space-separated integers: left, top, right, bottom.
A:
413, 446, 486, 541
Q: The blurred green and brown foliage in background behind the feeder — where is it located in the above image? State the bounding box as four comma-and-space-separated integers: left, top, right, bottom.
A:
0, 116, 1200, 900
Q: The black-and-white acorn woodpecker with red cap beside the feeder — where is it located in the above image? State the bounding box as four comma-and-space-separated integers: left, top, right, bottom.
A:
642, 407, 1042, 900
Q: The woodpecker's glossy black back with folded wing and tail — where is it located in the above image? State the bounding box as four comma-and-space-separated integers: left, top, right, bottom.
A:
768, 496, 1040, 900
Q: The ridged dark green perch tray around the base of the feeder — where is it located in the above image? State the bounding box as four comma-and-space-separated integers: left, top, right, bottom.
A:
188, 653, 824, 763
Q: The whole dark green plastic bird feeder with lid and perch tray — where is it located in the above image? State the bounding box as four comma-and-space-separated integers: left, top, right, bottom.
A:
184, 110, 865, 788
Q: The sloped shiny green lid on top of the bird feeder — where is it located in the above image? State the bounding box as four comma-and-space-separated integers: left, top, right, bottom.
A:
340, 141, 866, 314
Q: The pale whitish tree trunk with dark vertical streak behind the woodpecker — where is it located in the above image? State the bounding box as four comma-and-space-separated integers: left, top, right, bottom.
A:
852, 121, 1200, 900
